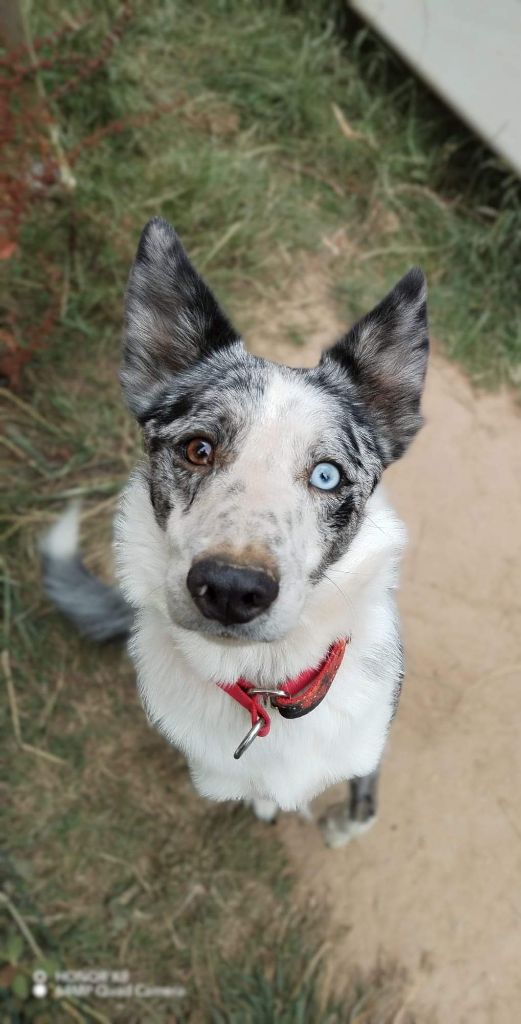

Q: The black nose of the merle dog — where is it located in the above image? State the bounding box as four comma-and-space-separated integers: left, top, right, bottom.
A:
186, 558, 278, 626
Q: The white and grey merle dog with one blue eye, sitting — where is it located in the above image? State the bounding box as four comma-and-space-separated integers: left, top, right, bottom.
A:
43, 218, 429, 846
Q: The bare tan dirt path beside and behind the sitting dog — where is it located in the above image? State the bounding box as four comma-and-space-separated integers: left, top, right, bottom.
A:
251, 266, 521, 1024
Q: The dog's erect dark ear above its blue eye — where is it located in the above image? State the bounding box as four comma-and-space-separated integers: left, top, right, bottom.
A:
322, 267, 429, 465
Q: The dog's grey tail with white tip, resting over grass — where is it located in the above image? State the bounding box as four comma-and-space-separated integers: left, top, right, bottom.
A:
41, 505, 134, 641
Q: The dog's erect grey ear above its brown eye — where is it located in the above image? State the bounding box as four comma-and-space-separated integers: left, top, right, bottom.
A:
121, 217, 240, 419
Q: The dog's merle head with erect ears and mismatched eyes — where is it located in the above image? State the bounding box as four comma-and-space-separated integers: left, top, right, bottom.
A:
121, 219, 428, 640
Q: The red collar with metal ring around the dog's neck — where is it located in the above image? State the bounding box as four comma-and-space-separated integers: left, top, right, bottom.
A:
219, 638, 349, 759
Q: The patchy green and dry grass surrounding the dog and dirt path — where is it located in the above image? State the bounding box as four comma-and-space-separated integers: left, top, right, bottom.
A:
0, 0, 521, 1024
